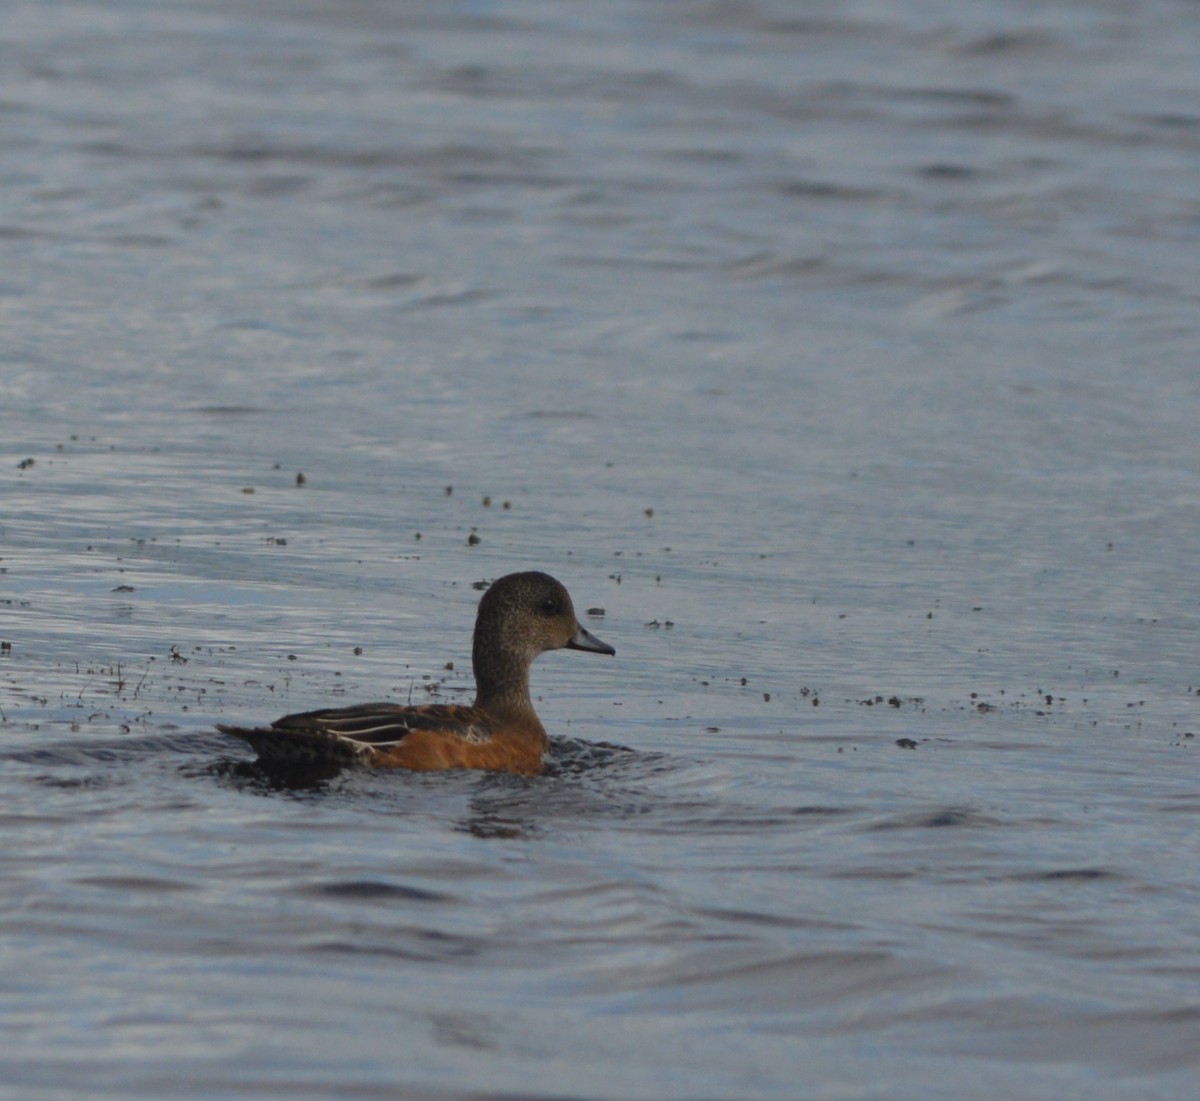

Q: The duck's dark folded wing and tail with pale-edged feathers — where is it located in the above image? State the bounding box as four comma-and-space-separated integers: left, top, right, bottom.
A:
217, 703, 491, 764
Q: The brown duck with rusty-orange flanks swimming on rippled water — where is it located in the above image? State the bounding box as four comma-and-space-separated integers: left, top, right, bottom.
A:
217, 571, 617, 776
